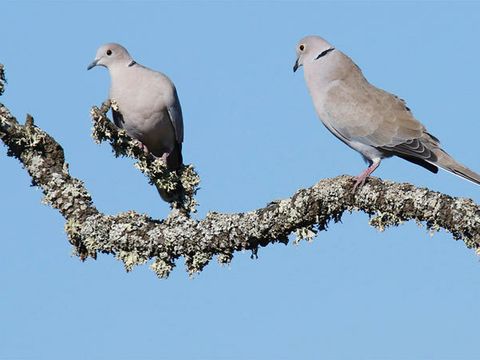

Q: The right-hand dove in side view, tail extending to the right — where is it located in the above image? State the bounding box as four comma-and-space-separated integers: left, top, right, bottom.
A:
293, 36, 480, 190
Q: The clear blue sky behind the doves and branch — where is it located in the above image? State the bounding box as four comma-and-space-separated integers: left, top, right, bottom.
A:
0, 1, 480, 360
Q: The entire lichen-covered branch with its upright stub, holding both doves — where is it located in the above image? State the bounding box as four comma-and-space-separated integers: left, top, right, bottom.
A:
0, 63, 480, 278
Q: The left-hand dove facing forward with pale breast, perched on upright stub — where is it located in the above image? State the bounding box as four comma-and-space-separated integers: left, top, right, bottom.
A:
87, 43, 183, 172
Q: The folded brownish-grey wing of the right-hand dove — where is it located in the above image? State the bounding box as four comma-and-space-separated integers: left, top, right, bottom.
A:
325, 75, 439, 162
